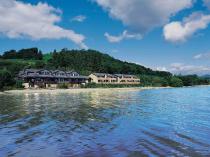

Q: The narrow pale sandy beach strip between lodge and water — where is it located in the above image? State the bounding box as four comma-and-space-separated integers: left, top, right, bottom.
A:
0, 87, 171, 94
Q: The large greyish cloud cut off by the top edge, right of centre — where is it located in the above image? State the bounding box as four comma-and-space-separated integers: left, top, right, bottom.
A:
93, 0, 193, 34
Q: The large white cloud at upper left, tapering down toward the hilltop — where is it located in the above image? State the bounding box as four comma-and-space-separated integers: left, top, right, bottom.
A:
0, 0, 87, 48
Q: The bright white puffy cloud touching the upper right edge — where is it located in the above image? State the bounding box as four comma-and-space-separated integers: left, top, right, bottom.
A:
163, 13, 210, 42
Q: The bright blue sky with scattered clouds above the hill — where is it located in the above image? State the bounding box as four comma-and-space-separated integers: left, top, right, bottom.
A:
0, 0, 210, 75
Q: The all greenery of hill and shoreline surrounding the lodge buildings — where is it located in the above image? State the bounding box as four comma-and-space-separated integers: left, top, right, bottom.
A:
0, 48, 210, 90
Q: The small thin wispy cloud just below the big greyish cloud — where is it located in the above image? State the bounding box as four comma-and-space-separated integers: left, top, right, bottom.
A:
104, 30, 142, 43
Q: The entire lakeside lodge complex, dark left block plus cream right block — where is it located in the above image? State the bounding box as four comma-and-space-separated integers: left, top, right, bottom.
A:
18, 69, 140, 88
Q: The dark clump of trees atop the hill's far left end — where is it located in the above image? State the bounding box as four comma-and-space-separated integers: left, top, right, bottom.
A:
1, 48, 43, 60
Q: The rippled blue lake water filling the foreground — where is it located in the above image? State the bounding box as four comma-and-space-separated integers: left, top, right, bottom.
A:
0, 87, 210, 157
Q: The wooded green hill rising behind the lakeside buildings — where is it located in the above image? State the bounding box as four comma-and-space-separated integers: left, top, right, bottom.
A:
0, 48, 171, 76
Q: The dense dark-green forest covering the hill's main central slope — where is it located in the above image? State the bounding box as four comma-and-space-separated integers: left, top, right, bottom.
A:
49, 49, 172, 77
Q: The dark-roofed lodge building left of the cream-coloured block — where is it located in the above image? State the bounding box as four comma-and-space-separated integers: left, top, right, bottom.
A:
18, 69, 89, 88
